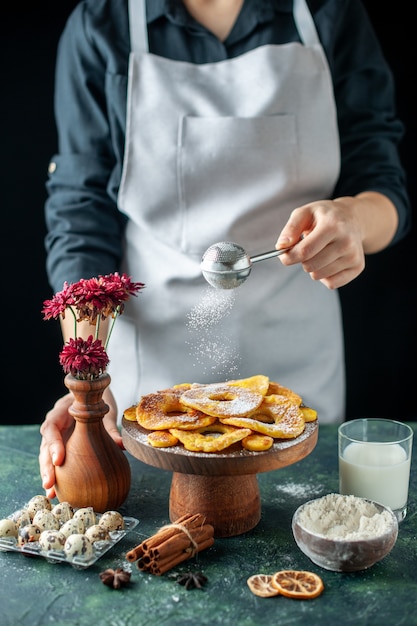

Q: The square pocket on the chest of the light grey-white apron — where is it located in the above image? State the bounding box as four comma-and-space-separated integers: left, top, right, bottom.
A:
177, 115, 297, 255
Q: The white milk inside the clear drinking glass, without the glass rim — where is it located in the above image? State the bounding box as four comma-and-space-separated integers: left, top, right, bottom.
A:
339, 436, 411, 510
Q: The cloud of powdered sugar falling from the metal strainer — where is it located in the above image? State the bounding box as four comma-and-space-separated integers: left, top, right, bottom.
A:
186, 287, 240, 377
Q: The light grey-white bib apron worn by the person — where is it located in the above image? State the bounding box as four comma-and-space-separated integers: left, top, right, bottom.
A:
114, 0, 345, 422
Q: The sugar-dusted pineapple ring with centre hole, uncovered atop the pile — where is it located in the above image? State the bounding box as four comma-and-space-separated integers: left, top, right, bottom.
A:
180, 383, 263, 417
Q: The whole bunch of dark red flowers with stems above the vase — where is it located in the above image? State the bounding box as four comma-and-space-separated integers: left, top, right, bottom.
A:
42, 272, 145, 379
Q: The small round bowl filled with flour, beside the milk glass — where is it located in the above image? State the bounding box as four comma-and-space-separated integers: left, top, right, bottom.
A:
292, 494, 398, 572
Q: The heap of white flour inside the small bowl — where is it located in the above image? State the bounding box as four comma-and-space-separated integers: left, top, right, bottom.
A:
299, 493, 392, 540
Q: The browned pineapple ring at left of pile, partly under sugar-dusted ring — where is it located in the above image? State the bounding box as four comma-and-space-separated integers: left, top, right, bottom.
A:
136, 389, 215, 430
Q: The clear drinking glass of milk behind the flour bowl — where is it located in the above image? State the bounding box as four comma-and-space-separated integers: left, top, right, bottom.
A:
338, 418, 413, 522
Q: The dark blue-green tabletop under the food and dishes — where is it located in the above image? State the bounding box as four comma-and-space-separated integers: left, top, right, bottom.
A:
0, 423, 417, 626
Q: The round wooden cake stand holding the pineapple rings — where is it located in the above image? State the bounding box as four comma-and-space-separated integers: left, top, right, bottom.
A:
122, 418, 318, 537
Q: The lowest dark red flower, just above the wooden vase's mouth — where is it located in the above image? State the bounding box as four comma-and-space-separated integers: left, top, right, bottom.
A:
59, 335, 109, 380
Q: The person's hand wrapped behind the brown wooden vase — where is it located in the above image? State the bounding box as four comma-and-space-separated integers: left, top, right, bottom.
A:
39, 388, 124, 499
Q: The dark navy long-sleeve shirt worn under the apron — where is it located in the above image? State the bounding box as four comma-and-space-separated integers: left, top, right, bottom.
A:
46, 0, 411, 291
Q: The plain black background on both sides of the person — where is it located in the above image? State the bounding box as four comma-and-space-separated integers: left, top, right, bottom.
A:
0, 0, 417, 424
